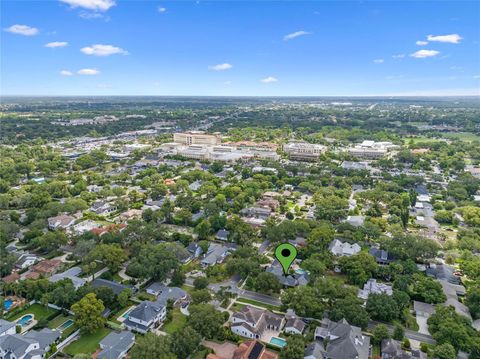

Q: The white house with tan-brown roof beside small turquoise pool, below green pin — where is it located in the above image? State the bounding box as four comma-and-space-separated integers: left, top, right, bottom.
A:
231, 305, 283, 339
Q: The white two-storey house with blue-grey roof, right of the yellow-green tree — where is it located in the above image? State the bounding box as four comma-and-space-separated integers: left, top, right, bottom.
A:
123, 301, 167, 334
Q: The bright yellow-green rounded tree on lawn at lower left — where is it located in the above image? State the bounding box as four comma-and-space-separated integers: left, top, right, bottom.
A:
71, 293, 105, 333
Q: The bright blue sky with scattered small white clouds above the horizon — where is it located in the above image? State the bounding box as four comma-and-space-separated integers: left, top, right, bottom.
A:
0, 0, 480, 96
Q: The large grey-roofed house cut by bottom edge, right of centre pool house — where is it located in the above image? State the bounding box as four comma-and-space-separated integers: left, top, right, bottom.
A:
307, 319, 371, 359
